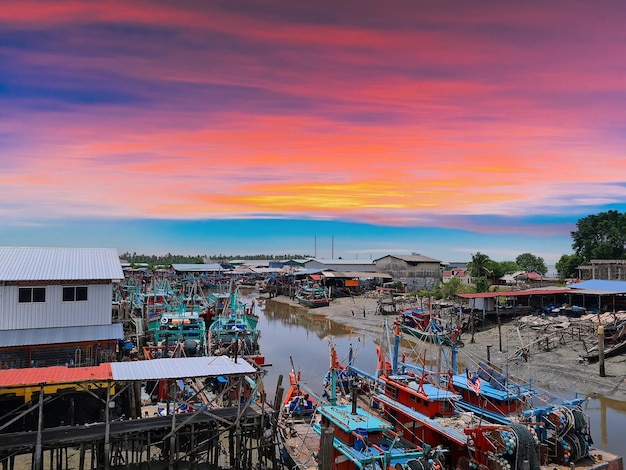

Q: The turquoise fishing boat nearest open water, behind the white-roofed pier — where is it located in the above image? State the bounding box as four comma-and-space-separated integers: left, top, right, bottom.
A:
208, 283, 265, 365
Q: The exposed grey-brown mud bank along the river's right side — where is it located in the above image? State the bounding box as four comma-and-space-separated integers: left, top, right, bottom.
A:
264, 296, 626, 402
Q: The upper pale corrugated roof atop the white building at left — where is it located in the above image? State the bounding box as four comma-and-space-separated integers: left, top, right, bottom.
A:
0, 247, 124, 281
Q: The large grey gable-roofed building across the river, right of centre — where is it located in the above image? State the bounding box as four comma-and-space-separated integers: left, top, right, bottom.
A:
374, 255, 441, 291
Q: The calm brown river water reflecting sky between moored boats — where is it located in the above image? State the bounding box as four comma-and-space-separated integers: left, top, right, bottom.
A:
258, 300, 626, 455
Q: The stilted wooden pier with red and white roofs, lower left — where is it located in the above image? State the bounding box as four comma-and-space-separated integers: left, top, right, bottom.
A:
0, 356, 282, 470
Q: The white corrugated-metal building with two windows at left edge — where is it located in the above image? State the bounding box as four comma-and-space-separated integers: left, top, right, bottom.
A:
0, 247, 124, 368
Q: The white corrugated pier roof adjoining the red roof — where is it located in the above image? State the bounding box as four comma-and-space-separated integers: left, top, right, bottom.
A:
111, 356, 256, 381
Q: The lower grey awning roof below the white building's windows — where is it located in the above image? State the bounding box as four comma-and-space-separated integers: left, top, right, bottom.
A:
0, 323, 124, 348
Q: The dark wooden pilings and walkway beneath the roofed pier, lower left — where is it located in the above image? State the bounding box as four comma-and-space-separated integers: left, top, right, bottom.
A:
0, 402, 283, 470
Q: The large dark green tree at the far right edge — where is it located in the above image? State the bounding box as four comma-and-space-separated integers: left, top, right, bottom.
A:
571, 210, 626, 261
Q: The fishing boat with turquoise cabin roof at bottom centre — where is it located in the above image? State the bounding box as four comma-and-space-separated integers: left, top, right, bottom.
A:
283, 344, 445, 470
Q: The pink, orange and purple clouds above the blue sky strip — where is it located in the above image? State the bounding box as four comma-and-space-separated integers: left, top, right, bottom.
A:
0, 2, 626, 229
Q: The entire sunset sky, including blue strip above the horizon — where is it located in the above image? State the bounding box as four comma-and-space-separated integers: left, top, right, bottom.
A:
0, 0, 626, 264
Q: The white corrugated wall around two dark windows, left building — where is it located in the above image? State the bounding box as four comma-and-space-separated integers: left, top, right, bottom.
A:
0, 284, 113, 334
